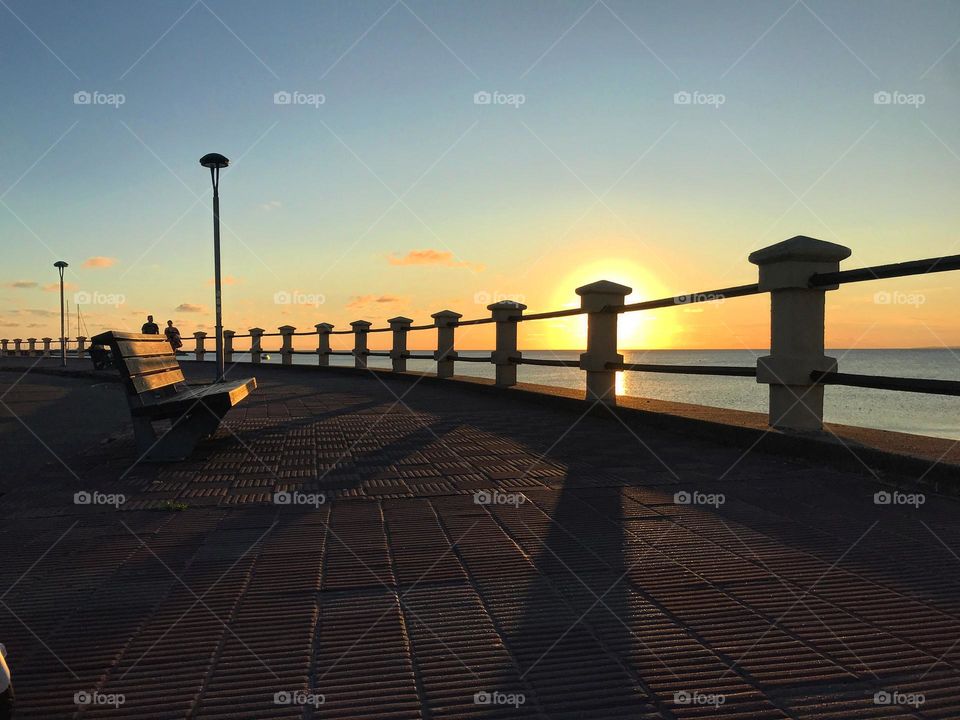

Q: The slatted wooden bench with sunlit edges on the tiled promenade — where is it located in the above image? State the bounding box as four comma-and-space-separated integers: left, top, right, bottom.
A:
92, 330, 257, 462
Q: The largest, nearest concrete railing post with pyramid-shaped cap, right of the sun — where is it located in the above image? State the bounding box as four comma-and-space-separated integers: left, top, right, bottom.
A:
749, 235, 850, 431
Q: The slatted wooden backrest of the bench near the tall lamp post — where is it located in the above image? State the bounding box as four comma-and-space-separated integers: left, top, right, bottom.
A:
92, 330, 184, 404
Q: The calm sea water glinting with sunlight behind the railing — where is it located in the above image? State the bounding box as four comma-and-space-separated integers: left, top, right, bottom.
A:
219, 349, 960, 440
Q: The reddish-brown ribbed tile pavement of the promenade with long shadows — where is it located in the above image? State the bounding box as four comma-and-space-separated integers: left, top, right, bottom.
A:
0, 368, 960, 720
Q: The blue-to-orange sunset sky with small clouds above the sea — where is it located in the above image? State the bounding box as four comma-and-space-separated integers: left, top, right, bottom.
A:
0, 0, 960, 349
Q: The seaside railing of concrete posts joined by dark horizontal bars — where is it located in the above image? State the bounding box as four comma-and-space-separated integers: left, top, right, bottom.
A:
2, 235, 960, 431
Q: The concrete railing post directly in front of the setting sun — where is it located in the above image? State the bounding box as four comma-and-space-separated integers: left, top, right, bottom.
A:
577, 280, 633, 405
